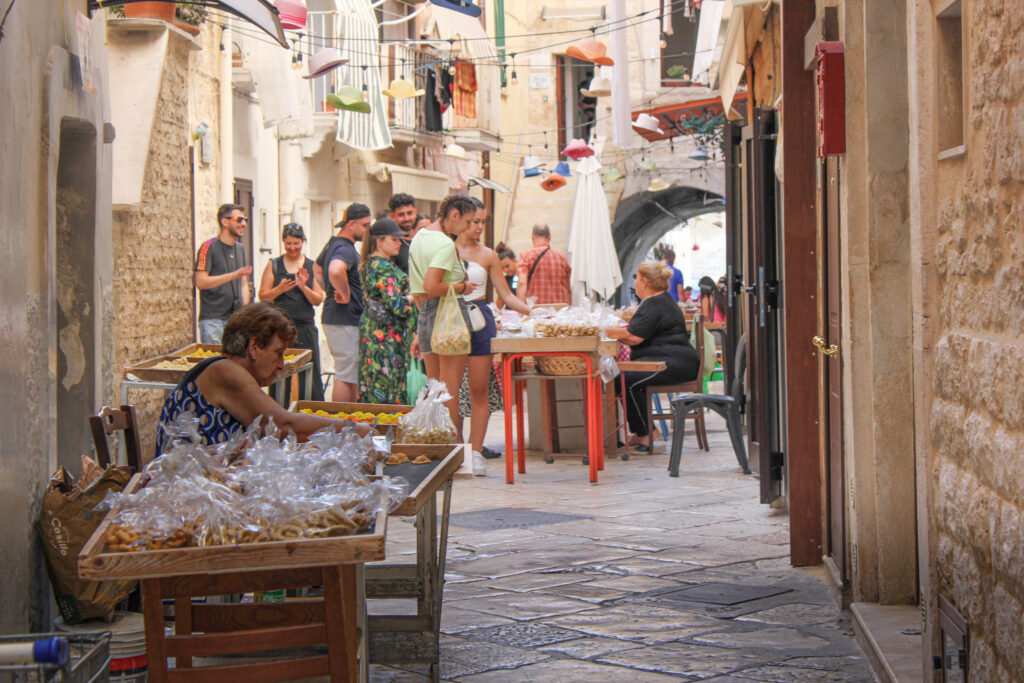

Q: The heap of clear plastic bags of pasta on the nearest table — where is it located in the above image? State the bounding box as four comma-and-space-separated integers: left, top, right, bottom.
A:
100, 416, 409, 551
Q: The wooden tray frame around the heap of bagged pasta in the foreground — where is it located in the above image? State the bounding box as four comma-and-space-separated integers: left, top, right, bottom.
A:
78, 473, 387, 580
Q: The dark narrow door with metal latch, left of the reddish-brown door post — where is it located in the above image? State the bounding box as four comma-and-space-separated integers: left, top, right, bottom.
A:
742, 110, 783, 503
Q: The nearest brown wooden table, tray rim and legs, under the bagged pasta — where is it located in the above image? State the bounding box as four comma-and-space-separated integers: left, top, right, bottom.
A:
78, 474, 387, 683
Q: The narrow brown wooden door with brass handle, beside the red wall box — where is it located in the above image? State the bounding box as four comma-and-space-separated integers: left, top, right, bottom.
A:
819, 157, 849, 586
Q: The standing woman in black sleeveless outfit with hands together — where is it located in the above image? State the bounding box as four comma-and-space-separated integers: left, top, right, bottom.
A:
259, 223, 324, 400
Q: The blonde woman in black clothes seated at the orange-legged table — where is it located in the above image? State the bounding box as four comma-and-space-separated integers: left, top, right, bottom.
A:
605, 261, 700, 453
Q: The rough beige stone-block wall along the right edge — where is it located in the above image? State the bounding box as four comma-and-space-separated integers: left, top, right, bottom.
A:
923, 0, 1024, 681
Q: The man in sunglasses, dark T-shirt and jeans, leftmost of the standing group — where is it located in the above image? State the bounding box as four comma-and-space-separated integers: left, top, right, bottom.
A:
196, 204, 253, 344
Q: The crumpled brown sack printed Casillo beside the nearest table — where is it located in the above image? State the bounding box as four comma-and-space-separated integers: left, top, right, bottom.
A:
39, 458, 136, 624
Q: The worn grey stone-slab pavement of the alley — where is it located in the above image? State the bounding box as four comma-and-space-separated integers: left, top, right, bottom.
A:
368, 415, 876, 683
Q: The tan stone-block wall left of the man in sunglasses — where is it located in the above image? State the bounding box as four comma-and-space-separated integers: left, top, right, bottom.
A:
113, 40, 195, 457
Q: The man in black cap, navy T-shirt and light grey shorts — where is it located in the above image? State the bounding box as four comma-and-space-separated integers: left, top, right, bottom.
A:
313, 203, 372, 401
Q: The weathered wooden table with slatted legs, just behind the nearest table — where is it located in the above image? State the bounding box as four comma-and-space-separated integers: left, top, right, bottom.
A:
366, 443, 469, 681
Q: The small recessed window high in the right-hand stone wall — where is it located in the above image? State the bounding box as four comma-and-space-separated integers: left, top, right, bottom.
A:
935, 0, 965, 158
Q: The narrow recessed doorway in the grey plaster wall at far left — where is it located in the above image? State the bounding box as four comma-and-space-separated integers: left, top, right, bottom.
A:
53, 119, 97, 471
